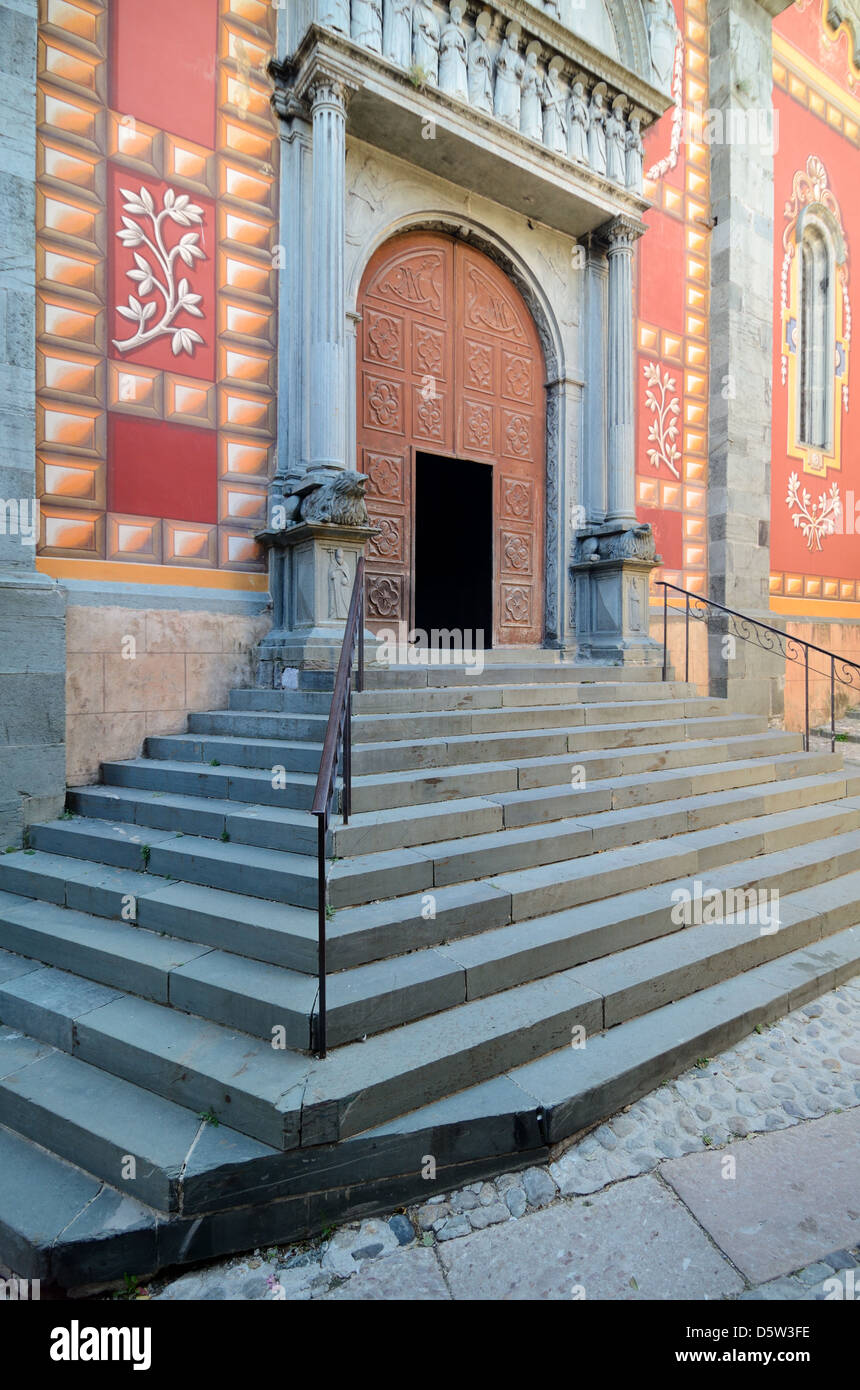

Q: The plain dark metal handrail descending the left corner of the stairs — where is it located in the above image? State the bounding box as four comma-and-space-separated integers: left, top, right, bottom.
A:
311, 556, 364, 1058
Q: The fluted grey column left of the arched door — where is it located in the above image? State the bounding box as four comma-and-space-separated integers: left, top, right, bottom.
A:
308, 74, 347, 468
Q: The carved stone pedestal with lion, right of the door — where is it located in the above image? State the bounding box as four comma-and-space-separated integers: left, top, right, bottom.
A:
571, 525, 661, 664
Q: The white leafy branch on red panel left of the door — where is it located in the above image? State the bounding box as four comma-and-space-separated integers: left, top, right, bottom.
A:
114, 188, 206, 357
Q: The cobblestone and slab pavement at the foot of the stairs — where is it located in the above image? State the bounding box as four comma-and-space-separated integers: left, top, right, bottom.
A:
149, 976, 860, 1300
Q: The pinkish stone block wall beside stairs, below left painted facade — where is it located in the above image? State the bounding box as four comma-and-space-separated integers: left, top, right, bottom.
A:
65, 602, 270, 785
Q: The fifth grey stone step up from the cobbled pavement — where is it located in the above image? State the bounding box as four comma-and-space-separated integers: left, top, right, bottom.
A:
0, 801, 860, 987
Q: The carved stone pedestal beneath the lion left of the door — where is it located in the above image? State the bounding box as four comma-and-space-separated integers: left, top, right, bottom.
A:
257, 521, 379, 688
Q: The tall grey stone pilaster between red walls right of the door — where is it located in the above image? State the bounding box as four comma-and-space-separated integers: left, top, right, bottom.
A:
707, 0, 788, 713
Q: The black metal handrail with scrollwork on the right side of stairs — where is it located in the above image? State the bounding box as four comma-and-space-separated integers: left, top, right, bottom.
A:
657, 580, 860, 752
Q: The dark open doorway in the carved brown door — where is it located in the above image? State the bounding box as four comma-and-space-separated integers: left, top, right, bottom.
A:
415, 453, 493, 649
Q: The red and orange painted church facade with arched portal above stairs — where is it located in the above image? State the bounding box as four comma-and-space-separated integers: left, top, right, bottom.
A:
0, 0, 860, 844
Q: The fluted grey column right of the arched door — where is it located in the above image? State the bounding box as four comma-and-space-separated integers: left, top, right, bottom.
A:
606, 217, 643, 524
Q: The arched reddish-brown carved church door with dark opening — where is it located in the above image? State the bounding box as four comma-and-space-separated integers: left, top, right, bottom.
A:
357, 232, 546, 646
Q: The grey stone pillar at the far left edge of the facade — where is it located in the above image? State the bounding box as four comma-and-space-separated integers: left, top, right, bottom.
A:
0, 0, 65, 852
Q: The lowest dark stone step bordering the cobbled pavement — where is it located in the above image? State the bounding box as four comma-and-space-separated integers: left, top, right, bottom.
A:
0, 929, 860, 1291
